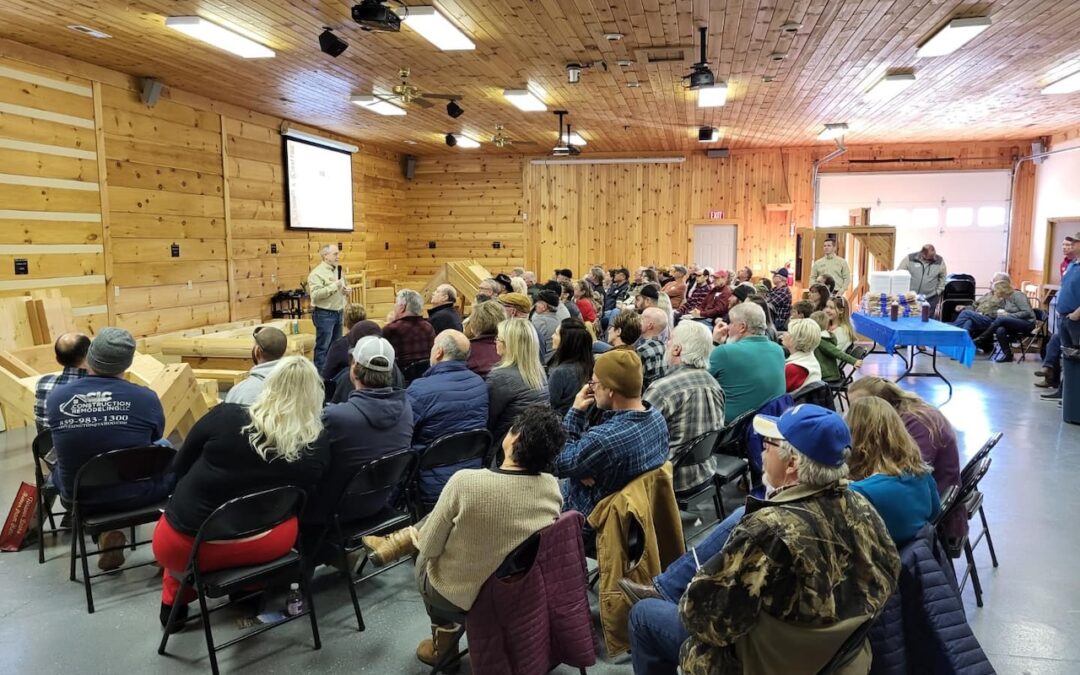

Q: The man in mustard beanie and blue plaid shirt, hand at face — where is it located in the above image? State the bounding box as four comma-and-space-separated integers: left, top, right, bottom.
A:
555, 349, 667, 517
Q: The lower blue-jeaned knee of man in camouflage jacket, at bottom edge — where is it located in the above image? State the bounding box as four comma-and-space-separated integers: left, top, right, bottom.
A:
630, 597, 690, 675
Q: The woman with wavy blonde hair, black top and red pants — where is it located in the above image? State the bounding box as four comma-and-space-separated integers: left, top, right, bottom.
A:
153, 356, 329, 631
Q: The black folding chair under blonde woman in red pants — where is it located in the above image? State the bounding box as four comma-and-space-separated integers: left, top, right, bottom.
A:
158, 485, 322, 675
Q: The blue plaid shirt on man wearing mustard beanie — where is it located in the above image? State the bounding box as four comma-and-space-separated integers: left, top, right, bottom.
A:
555, 404, 667, 517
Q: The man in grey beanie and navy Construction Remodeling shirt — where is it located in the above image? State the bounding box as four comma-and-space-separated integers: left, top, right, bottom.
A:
45, 327, 175, 569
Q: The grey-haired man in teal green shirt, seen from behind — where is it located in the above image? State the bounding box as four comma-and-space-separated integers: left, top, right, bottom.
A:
708, 303, 785, 420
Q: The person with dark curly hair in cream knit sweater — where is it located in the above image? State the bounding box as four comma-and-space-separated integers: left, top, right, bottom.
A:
364, 405, 565, 665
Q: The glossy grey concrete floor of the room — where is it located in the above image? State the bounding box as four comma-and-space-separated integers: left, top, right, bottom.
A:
0, 356, 1080, 675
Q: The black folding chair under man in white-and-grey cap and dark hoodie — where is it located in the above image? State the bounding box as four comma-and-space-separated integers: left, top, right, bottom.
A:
326, 449, 418, 631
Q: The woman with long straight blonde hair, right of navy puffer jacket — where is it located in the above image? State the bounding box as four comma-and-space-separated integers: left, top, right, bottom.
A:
487, 319, 548, 447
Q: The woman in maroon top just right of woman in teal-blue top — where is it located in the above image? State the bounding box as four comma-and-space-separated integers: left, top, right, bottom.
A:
848, 377, 968, 540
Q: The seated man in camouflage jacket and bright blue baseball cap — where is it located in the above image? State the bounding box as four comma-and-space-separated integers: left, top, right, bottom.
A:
621, 405, 900, 675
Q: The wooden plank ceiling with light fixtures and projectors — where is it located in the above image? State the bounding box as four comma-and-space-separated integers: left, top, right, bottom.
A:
0, 0, 1080, 154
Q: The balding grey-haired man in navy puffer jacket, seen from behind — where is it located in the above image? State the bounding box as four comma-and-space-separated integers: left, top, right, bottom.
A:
406, 329, 487, 504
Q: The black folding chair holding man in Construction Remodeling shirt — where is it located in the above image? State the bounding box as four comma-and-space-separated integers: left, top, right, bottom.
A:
68, 445, 176, 613
